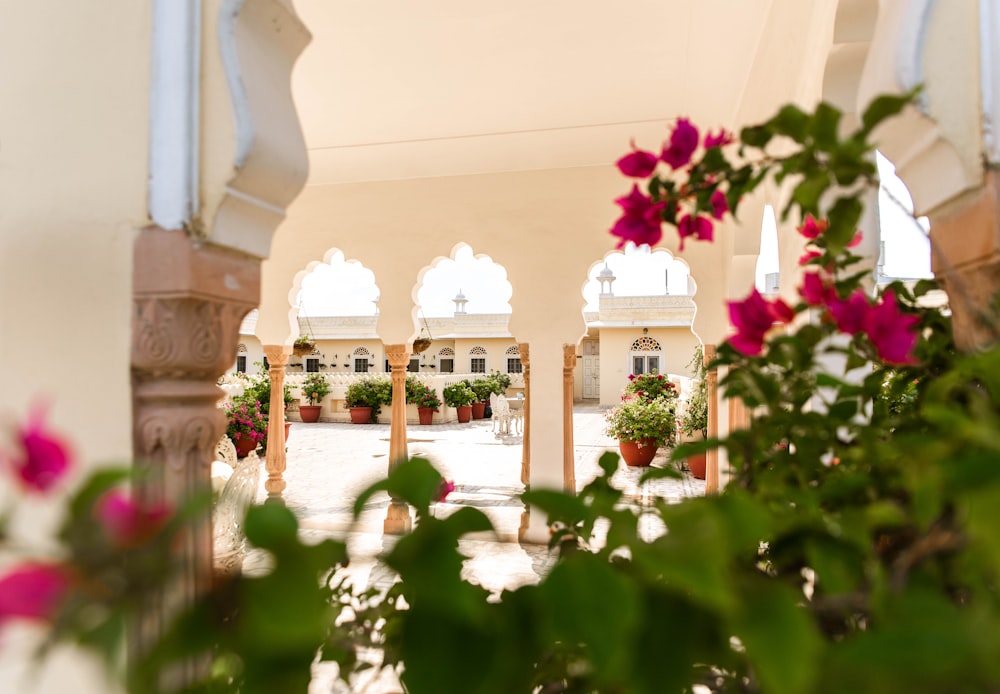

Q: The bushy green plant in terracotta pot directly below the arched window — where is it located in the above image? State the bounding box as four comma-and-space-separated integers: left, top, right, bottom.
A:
605, 395, 677, 467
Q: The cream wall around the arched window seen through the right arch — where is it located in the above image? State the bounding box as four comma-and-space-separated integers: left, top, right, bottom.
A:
596, 328, 698, 405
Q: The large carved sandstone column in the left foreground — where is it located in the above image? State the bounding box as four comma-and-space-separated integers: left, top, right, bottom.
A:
129, 227, 260, 682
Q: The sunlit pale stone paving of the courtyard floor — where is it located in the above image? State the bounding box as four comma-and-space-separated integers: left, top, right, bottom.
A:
245, 405, 705, 694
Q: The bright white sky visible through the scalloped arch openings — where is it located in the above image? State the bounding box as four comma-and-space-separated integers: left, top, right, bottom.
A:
299, 154, 931, 318
